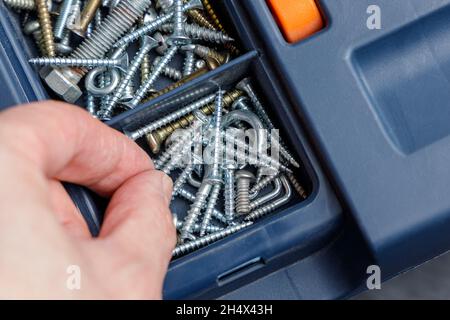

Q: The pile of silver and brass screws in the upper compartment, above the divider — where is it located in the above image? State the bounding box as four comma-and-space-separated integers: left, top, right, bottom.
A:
4, 0, 239, 121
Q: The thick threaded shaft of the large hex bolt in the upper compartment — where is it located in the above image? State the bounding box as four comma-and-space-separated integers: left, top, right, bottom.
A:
71, 0, 150, 70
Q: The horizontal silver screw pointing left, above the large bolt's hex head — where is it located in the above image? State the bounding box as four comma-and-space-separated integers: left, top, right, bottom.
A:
28, 54, 128, 70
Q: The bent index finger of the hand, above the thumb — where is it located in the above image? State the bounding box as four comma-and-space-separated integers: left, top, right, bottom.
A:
0, 101, 154, 195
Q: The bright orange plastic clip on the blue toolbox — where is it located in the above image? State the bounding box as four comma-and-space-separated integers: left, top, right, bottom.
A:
267, 0, 325, 43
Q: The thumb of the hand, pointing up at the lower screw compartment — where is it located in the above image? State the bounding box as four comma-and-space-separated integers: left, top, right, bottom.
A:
84, 170, 176, 298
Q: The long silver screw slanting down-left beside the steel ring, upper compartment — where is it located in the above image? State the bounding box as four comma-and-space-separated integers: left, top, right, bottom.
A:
100, 36, 158, 119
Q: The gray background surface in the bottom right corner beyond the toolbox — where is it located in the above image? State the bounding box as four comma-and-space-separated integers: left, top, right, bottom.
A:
355, 253, 450, 300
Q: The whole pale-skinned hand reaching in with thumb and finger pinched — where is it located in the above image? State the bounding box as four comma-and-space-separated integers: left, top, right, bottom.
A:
0, 101, 176, 299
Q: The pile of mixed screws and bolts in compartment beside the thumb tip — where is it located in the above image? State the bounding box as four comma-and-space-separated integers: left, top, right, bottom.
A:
127, 78, 307, 257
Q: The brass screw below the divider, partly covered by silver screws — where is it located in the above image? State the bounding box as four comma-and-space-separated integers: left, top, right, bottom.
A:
146, 89, 243, 154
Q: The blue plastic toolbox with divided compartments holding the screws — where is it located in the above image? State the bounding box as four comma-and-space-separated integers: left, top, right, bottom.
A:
0, 0, 450, 299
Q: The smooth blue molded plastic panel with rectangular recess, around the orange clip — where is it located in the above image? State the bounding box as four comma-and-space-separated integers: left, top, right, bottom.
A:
239, 0, 450, 277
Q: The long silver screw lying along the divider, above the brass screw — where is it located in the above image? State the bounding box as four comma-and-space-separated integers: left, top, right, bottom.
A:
127, 94, 216, 140
